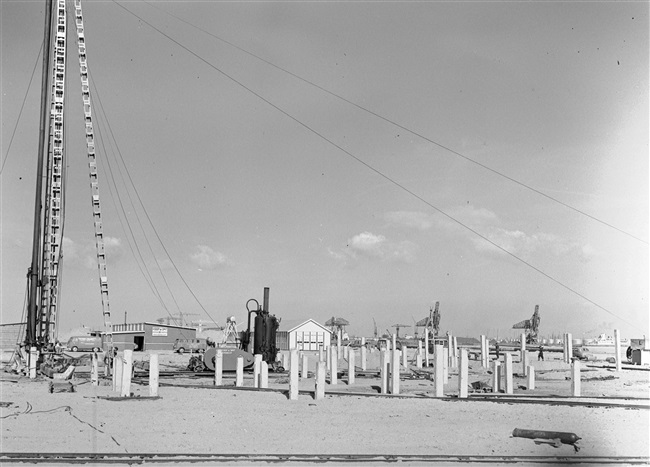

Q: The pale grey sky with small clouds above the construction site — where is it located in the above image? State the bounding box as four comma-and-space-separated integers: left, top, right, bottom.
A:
0, 0, 649, 344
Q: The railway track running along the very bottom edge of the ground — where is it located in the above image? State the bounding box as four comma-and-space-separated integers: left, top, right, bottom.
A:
0, 452, 650, 465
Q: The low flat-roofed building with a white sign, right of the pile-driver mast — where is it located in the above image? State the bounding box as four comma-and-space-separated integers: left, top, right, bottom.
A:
113, 322, 196, 351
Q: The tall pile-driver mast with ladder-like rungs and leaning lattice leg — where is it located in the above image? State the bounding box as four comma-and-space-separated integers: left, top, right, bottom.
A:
25, 0, 112, 358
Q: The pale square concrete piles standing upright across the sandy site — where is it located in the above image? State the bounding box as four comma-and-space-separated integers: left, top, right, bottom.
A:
102, 330, 621, 400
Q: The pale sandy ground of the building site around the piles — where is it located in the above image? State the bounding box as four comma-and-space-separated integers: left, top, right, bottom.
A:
0, 352, 650, 466
